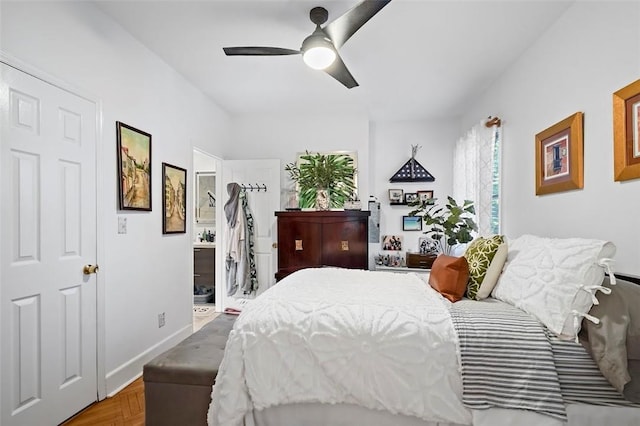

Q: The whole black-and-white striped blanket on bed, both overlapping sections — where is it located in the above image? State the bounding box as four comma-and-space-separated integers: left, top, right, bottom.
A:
450, 299, 640, 421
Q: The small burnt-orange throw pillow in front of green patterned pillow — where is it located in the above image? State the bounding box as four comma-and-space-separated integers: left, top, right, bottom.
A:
429, 254, 469, 302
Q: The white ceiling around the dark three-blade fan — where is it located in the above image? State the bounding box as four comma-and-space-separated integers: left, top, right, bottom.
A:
96, 0, 573, 120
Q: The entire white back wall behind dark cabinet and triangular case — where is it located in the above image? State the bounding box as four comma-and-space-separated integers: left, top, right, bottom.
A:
228, 115, 458, 264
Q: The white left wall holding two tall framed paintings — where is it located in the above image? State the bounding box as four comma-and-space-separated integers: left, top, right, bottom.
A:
0, 2, 229, 392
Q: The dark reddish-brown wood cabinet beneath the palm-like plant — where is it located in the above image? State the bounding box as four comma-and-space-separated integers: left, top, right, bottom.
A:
276, 210, 371, 281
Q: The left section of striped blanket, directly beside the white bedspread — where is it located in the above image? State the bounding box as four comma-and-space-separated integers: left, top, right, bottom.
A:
451, 300, 567, 421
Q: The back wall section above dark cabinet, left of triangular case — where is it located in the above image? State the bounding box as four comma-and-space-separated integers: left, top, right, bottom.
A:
227, 115, 370, 208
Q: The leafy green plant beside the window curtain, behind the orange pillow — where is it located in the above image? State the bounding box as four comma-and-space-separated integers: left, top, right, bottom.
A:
409, 196, 478, 254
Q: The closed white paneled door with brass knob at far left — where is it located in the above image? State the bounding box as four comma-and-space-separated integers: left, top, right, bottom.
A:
0, 64, 97, 426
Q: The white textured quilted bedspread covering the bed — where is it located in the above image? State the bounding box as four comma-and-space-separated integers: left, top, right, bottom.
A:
208, 268, 471, 426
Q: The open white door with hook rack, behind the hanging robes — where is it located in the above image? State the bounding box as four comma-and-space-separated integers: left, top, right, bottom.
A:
216, 160, 280, 307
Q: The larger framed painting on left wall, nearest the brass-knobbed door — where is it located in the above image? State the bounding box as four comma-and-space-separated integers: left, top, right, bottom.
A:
116, 121, 151, 211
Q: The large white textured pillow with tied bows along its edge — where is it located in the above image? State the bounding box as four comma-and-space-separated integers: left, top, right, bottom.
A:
491, 235, 616, 339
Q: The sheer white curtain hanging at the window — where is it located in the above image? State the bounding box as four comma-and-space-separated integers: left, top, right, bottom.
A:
453, 120, 501, 236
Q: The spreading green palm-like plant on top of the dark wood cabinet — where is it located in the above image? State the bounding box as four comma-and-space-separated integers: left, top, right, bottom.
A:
284, 151, 356, 210
